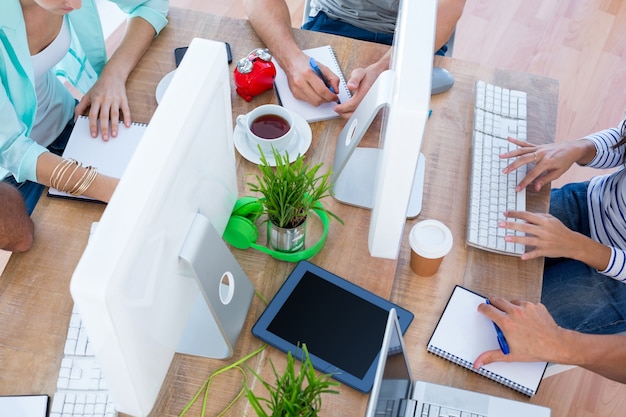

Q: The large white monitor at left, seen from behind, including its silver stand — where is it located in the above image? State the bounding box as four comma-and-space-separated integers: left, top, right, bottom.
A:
70, 39, 254, 417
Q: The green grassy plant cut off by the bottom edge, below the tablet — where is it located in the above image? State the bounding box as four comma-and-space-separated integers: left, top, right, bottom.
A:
246, 345, 339, 417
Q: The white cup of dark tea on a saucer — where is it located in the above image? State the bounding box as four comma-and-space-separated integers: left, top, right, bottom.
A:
237, 104, 295, 156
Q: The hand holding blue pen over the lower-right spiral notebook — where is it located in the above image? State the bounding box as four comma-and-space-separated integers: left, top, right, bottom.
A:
474, 298, 565, 369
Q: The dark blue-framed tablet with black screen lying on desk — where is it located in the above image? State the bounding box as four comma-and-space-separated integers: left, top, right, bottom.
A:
252, 261, 413, 392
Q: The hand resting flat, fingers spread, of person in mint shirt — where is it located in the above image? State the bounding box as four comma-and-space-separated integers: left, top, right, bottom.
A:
74, 68, 131, 141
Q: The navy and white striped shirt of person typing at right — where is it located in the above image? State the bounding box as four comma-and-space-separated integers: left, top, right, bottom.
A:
585, 123, 626, 283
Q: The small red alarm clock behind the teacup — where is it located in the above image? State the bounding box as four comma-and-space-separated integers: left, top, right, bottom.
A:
233, 48, 276, 101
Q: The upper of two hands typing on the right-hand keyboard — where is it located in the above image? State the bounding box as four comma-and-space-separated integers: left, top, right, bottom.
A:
500, 138, 580, 191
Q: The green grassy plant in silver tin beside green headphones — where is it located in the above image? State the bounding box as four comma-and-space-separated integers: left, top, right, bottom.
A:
248, 148, 343, 252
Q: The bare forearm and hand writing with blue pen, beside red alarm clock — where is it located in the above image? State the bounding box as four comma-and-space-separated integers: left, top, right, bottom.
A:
244, 0, 339, 106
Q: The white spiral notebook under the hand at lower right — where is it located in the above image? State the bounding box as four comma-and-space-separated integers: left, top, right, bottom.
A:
427, 285, 548, 397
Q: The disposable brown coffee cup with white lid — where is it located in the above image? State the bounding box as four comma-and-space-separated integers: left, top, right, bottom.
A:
409, 220, 452, 277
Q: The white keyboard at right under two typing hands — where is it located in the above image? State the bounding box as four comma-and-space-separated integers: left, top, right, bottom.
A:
466, 81, 527, 255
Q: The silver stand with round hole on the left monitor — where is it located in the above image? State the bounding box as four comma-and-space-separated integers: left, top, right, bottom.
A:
176, 213, 254, 359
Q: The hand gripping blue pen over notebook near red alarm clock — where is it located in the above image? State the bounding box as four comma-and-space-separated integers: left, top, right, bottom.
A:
283, 53, 339, 106
